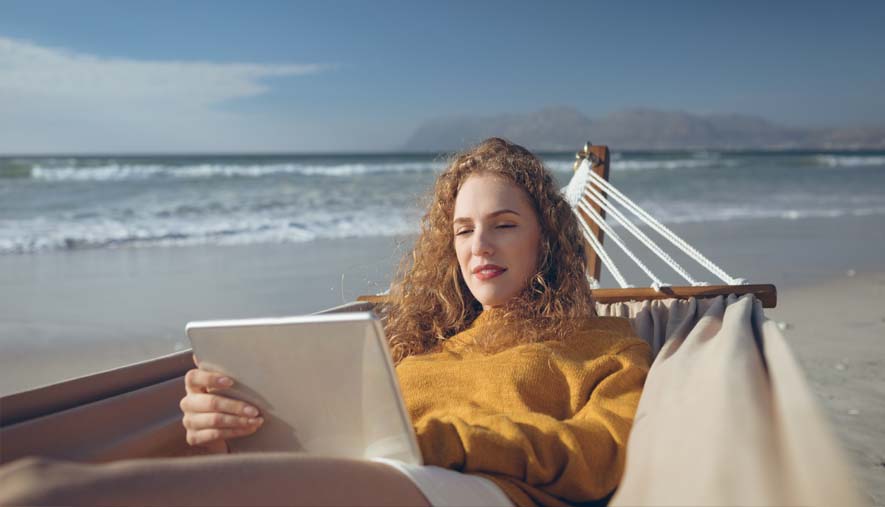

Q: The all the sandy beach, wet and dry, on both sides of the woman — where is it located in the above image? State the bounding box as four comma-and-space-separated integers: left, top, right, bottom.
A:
0, 212, 885, 505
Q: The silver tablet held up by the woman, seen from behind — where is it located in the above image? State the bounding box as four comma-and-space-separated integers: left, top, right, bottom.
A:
185, 312, 422, 465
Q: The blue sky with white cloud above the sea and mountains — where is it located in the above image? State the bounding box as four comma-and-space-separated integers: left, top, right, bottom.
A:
0, 0, 885, 155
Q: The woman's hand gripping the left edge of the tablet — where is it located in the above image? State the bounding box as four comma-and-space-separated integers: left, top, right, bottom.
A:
180, 357, 264, 453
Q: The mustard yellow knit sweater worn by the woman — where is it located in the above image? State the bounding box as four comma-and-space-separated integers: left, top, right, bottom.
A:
397, 312, 650, 506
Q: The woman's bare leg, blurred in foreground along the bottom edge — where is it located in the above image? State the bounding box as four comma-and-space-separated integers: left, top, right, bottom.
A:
0, 453, 429, 506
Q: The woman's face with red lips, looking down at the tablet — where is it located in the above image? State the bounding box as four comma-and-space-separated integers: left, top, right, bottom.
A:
453, 174, 541, 309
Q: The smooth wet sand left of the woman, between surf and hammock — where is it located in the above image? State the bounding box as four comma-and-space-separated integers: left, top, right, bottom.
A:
0, 238, 401, 396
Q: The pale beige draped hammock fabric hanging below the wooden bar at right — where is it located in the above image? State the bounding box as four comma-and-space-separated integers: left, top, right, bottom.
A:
597, 295, 863, 506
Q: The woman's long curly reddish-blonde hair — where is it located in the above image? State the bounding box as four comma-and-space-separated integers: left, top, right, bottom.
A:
376, 137, 594, 363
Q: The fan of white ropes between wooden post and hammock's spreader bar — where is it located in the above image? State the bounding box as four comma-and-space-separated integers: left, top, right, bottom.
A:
562, 159, 746, 290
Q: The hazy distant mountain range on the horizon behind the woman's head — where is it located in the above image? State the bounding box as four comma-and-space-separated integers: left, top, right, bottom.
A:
403, 107, 885, 151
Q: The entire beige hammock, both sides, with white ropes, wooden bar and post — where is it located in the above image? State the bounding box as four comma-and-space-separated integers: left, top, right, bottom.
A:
0, 145, 862, 506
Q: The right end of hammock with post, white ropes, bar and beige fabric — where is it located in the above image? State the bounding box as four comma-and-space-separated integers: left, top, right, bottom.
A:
563, 144, 862, 505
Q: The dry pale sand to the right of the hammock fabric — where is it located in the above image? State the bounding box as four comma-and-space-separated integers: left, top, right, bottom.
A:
766, 271, 885, 505
